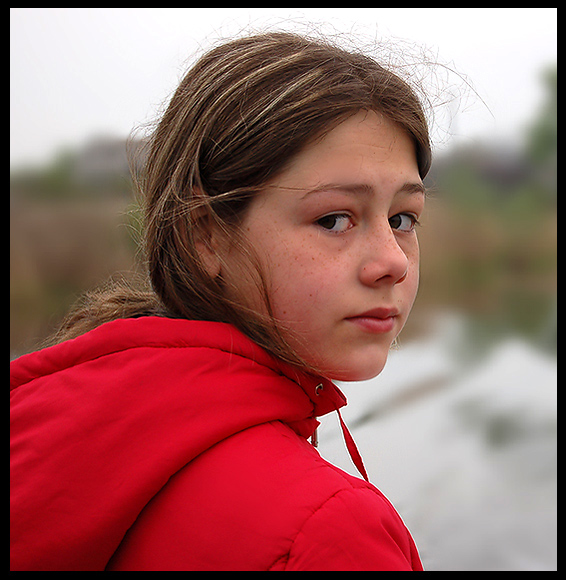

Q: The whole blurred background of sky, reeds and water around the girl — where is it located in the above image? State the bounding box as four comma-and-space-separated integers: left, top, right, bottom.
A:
10, 8, 557, 571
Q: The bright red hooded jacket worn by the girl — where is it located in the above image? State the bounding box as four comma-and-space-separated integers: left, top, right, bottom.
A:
11, 318, 422, 571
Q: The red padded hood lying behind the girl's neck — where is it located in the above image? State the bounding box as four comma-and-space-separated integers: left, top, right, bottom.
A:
10, 317, 346, 570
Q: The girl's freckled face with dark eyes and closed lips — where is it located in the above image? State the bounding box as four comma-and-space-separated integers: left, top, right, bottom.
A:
223, 111, 425, 381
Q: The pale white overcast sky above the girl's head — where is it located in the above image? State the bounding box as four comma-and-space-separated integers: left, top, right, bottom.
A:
10, 8, 557, 166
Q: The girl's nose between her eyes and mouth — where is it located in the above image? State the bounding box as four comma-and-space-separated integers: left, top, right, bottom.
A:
360, 224, 409, 286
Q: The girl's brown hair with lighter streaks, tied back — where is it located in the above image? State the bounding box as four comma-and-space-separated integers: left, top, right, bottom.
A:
54, 32, 431, 364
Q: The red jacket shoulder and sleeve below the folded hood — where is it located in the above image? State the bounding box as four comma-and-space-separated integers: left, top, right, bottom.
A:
117, 421, 422, 571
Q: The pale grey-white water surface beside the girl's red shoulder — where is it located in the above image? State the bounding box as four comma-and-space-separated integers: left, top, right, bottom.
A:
319, 318, 557, 571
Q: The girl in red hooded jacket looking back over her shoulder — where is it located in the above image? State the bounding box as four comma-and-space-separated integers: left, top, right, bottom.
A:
11, 33, 431, 571
